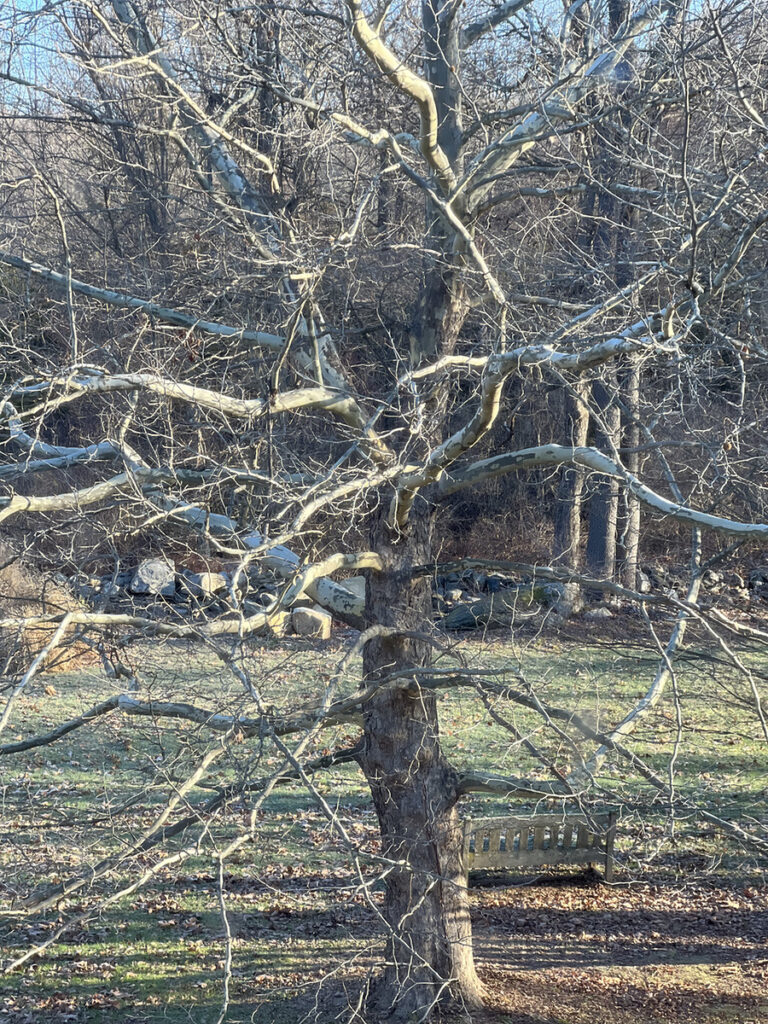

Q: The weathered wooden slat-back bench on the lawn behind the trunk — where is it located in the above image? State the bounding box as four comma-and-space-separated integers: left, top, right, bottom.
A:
464, 811, 616, 882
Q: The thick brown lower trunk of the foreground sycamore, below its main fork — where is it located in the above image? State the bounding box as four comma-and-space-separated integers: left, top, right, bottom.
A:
360, 499, 481, 1021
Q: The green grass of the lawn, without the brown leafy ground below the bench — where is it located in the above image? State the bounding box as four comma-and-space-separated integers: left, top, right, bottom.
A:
0, 637, 768, 1024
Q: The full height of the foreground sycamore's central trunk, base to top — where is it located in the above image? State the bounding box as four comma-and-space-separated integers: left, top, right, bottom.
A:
360, 9, 482, 991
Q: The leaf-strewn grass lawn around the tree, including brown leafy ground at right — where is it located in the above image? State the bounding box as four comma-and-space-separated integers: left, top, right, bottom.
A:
0, 618, 768, 1024
